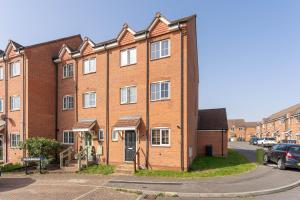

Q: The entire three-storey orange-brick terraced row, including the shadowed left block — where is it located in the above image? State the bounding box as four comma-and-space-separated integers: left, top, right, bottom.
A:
0, 13, 204, 170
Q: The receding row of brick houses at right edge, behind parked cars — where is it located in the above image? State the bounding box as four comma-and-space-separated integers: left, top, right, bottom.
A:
256, 104, 300, 143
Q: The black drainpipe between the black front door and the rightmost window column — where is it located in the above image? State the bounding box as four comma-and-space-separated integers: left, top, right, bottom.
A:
145, 31, 149, 169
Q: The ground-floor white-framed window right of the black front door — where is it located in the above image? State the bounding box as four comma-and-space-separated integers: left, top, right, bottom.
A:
151, 128, 170, 146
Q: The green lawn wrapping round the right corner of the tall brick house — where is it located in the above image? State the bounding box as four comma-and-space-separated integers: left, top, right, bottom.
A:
136, 150, 256, 178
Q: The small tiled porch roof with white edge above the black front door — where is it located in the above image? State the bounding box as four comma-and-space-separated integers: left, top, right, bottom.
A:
114, 116, 141, 130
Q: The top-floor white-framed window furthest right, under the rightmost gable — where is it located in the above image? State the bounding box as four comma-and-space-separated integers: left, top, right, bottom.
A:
151, 39, 170, 60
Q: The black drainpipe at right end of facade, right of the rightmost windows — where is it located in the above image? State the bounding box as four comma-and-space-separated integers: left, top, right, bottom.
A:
178, 23, 184, 171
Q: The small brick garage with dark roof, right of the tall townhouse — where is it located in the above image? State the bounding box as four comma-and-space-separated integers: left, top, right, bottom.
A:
197, 108, 228, 156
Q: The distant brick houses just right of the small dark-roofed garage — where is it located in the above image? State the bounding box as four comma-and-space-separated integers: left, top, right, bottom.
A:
228, 119, 257, 142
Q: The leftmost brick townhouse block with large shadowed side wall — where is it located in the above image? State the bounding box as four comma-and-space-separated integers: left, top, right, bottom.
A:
0, 35, 82, 162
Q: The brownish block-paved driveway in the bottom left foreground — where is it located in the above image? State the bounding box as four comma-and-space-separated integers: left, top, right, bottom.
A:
0, 174, 138, 200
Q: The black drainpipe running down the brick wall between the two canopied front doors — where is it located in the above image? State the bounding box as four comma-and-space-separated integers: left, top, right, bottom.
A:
104, 45, 110, 165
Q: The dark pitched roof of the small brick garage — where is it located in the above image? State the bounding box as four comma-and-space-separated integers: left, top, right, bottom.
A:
198, 108, 228, 130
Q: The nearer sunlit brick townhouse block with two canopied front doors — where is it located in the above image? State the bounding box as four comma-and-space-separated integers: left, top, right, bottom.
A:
55, 13, 199, 170
